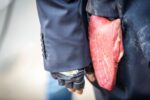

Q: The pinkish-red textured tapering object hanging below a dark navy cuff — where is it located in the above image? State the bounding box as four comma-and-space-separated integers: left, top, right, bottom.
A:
89, 16, 124, 90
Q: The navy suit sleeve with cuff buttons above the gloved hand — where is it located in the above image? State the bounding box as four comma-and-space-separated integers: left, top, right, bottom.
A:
37, 0, 91, 72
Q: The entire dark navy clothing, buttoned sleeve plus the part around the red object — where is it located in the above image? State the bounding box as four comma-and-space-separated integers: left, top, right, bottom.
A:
37, 0, 150, 100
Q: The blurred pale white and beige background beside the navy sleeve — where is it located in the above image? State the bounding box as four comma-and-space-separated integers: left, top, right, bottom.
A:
0, 0, 95, 100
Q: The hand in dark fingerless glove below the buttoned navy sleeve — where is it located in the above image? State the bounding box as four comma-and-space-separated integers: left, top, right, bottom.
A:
51, 69, 85, 94
